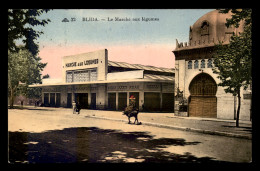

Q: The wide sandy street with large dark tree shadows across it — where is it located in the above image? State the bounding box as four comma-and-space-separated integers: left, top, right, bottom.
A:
8, 107, 252, 163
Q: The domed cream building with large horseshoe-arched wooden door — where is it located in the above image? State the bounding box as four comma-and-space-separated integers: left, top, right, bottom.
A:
173, 10, 252, 120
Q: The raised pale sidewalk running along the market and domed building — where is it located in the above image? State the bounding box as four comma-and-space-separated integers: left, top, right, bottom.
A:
80, 109, 252, 139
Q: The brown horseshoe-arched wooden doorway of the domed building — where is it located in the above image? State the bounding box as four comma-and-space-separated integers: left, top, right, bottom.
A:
188, 73, 217, 118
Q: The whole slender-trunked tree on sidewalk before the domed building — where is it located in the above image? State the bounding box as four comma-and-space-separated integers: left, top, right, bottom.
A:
213, 9, 252, 127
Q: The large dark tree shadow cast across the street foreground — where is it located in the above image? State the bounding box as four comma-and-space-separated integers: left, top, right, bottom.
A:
9, 127, 232, 163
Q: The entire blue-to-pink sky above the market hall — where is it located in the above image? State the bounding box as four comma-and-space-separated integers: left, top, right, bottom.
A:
30, 9, 214, 78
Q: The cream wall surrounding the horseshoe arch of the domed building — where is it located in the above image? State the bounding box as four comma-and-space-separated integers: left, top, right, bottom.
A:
175, 59, 251, 120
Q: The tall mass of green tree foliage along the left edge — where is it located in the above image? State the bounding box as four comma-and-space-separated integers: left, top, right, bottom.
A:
8, 9, 50, 108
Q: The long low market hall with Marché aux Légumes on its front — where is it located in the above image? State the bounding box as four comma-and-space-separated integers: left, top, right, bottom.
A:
30, 49, 174, 112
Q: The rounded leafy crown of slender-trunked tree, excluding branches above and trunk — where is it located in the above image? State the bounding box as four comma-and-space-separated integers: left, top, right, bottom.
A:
213, 36, 252, 96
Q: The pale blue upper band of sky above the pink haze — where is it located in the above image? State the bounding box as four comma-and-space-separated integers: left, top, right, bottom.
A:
35, 9, 214, 48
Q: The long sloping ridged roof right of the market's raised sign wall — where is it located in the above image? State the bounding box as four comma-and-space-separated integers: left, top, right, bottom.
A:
108, 61, 174, 73
